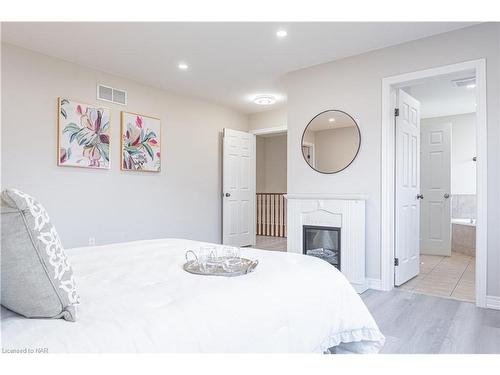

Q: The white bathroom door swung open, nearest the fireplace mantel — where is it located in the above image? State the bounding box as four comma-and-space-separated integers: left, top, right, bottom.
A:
394, 90, 420, 285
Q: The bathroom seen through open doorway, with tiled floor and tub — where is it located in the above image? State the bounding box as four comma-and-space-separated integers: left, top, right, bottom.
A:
395, 71, 477, 302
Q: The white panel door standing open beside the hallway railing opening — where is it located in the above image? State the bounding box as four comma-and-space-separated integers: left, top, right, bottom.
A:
222, 129, 256, 246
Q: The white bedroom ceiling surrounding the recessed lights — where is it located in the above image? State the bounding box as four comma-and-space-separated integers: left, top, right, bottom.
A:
2, 22, 472, 113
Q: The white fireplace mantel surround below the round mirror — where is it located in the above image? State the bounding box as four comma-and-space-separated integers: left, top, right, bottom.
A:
286, 194, 368, 293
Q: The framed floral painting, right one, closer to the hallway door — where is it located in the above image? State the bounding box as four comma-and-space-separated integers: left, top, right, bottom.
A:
121, 112, 161, 172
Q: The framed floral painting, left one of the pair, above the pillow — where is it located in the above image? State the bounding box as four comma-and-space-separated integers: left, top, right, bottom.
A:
57, 98, 110, 169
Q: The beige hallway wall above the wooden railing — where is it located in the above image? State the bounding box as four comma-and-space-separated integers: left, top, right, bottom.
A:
257, 134, 287, 193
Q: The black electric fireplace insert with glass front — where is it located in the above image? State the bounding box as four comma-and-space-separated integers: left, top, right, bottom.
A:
302, 225, 341, 271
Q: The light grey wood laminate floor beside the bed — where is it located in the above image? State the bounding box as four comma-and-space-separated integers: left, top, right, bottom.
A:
361, 289, 500, 354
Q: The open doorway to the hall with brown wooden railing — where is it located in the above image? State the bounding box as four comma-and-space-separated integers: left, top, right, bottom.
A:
256, 130, 287, 251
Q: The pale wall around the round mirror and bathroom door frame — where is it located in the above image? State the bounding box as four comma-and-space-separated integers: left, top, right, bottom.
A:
286, 24, 500, 296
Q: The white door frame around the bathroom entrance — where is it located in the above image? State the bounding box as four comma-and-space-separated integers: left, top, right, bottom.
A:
380, 59, 488, 307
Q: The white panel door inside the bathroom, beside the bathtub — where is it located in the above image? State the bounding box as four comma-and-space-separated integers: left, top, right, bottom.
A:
420, 123, 451, 256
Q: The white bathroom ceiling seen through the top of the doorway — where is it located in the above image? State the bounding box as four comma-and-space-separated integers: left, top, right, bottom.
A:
404, 71, 476, 118
